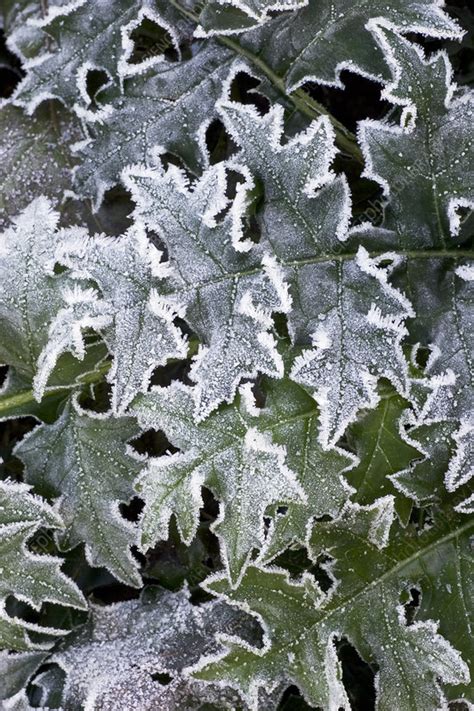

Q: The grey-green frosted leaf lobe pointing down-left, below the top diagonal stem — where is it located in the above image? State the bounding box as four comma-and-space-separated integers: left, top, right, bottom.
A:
76, 45, 232, 207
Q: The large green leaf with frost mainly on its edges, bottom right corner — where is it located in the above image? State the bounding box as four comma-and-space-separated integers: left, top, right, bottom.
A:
195, 497, 472, 711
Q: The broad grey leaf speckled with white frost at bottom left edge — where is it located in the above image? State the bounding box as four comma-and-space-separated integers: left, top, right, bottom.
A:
51, 588, 266, 711
